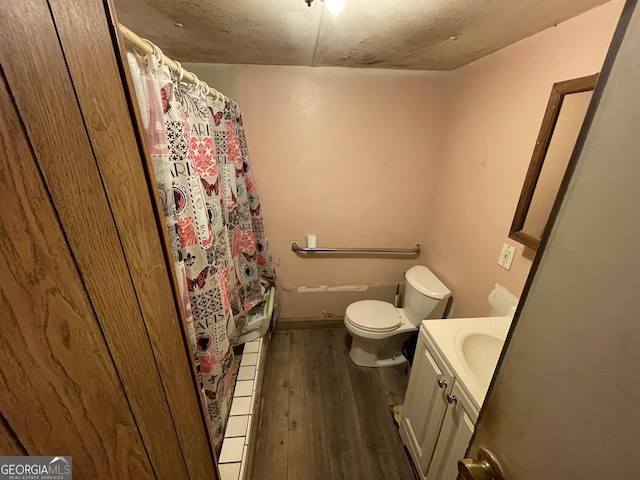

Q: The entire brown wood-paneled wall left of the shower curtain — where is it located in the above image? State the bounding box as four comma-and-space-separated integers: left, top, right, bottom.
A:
0, 0, 217, 479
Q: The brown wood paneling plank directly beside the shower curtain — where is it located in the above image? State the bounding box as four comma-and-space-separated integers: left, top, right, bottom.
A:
49, 0, 219, 478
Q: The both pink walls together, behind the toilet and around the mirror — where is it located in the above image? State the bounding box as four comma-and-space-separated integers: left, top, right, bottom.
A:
238, 0, 623, 319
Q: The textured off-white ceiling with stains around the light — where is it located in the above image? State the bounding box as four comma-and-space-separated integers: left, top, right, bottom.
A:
114, 0, 606, 70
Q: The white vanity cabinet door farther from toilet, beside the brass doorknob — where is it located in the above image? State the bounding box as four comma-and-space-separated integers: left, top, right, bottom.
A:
427, 383, 478, 480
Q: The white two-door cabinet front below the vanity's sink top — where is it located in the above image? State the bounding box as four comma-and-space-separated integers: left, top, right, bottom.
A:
400, 328, 478, 480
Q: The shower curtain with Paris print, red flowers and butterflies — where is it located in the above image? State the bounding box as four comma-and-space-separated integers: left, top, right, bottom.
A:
128, 52, 274, 452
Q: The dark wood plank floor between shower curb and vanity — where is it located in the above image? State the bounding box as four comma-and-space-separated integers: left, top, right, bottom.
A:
251, 329, 415, 480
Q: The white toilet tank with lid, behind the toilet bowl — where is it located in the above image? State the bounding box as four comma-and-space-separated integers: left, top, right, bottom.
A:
404, 265, 451, 326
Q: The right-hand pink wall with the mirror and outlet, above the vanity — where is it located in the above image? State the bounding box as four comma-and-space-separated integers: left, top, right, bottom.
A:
424, 1, 623, 317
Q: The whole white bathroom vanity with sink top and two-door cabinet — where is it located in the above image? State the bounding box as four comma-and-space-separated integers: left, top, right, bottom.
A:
400, 316, 512, 480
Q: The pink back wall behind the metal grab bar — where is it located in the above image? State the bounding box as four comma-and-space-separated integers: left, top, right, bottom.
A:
239, 66, 448, 318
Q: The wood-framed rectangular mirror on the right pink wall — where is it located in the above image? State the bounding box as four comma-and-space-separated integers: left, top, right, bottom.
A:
509, 73, 599, 250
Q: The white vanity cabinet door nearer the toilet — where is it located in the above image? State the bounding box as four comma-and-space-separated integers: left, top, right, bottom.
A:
400, 332, 454, 474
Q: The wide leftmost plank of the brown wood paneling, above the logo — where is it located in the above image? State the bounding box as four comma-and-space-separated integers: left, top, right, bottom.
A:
0, 70, 154, 479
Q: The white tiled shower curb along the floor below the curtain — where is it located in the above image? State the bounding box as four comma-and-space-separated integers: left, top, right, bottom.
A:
218, 337, 263, 480
